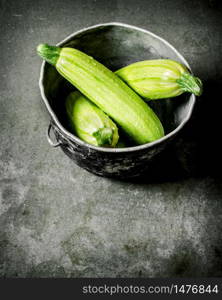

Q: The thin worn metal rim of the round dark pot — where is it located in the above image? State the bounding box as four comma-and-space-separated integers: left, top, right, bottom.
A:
39, 22, 196, 153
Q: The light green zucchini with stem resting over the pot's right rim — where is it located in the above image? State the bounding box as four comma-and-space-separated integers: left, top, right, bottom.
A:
116, 59, 202, 100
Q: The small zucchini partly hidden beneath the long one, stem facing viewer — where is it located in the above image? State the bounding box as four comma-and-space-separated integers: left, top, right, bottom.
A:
65, 91, 119, 147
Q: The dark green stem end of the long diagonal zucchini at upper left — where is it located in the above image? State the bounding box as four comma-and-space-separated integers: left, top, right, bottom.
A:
37, 44, 61, 66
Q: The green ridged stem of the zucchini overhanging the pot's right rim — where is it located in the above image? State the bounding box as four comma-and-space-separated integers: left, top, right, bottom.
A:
176, 72, 203, 96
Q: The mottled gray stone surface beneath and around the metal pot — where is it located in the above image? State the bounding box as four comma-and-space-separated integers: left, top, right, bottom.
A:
0, 0, 222, 277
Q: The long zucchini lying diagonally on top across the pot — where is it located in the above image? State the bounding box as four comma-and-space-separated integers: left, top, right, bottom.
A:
37, 44, 164, 144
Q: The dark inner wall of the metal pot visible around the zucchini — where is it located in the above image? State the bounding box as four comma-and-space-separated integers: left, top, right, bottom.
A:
43, 25, 194, 146
